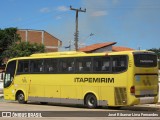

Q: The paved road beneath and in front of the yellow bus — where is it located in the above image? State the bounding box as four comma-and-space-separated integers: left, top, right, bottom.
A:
0, 99, 160, 120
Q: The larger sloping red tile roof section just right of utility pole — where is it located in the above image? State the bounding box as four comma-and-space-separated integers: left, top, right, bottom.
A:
79, 42, 116, 52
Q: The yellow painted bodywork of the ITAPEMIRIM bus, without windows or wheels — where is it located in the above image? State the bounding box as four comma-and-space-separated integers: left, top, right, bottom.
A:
4, 51, 158, 106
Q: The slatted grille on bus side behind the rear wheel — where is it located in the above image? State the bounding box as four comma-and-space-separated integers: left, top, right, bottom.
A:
114, 87, 127, 105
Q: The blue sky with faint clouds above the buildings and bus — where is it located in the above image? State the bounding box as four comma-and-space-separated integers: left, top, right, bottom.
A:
0, 0, 160, 51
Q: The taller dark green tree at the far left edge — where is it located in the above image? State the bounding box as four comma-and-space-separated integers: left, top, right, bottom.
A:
0, 28, 20, 51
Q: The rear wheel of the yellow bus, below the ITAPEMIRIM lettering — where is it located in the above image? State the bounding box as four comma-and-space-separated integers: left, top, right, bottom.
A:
85, 94, 97, 109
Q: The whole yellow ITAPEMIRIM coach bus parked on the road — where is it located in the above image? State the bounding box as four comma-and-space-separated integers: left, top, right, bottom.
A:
4, 51, 159, 108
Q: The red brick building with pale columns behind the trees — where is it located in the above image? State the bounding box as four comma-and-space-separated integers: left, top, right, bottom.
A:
17, 29, 62, 52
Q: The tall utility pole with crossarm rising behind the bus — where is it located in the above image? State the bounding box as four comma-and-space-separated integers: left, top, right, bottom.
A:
70, 6, 86, 51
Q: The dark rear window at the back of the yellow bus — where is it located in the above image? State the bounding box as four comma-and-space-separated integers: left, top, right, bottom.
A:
134, 53, 157, 67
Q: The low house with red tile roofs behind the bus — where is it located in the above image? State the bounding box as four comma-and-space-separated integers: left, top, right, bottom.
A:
79, 42, 134, 53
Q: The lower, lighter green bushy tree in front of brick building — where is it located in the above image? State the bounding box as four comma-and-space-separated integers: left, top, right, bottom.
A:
2, 42, 45, 59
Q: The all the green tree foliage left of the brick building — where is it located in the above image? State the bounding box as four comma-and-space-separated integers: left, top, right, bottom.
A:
0, 28, 45, 60
